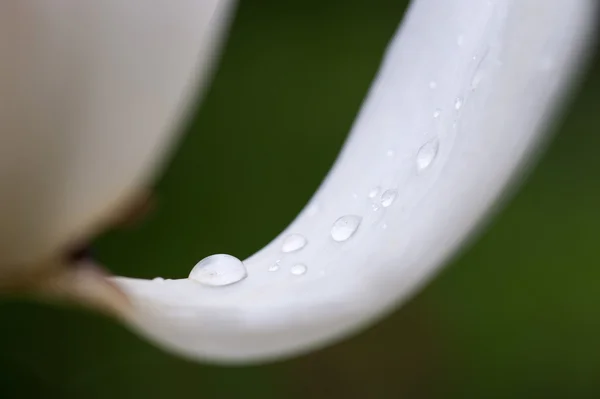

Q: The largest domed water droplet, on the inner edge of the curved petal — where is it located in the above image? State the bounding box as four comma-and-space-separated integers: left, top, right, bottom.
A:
188, 254, 248, 286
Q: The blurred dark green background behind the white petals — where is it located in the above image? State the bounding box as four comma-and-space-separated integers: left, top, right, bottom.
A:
0, 0, 600, 399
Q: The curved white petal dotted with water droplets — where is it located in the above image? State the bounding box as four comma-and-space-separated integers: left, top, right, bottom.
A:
116, 0, 595, 362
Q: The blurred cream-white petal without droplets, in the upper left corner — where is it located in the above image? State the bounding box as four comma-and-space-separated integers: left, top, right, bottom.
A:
0, 0, 233, 268
